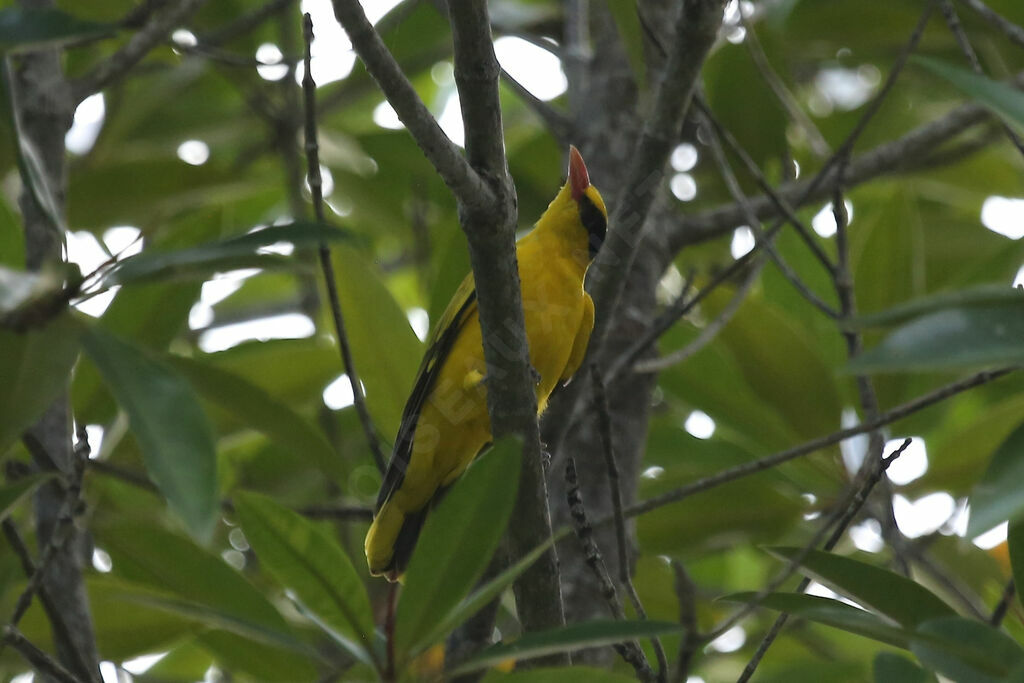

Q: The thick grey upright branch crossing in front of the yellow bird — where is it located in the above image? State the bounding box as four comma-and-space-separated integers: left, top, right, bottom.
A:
449, 1, 567, 643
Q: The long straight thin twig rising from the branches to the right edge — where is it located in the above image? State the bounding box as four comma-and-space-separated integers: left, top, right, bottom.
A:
618, 368, 1018, 524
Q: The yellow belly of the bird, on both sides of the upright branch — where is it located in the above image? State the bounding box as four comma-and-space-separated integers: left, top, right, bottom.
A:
392, 280, 584, 510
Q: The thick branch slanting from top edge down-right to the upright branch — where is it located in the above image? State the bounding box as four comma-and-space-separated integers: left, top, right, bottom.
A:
334, 0, 494, 207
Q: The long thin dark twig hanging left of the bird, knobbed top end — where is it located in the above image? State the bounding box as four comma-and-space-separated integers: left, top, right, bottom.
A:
302, 12, 387, 472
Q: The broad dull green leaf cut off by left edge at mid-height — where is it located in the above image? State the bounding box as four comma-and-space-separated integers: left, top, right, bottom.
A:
0, 314, 82, 454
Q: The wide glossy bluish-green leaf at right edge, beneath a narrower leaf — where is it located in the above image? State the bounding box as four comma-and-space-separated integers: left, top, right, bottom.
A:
847, 295, 1024, 373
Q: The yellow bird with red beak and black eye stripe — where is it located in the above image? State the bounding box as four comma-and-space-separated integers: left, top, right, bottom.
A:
366, 146, 608, 581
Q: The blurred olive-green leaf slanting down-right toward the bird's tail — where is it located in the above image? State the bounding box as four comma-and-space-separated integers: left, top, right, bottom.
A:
170, 356, 344, 481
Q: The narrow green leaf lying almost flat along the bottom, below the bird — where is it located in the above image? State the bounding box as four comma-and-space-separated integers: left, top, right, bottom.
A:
450, 622, 685, 676
